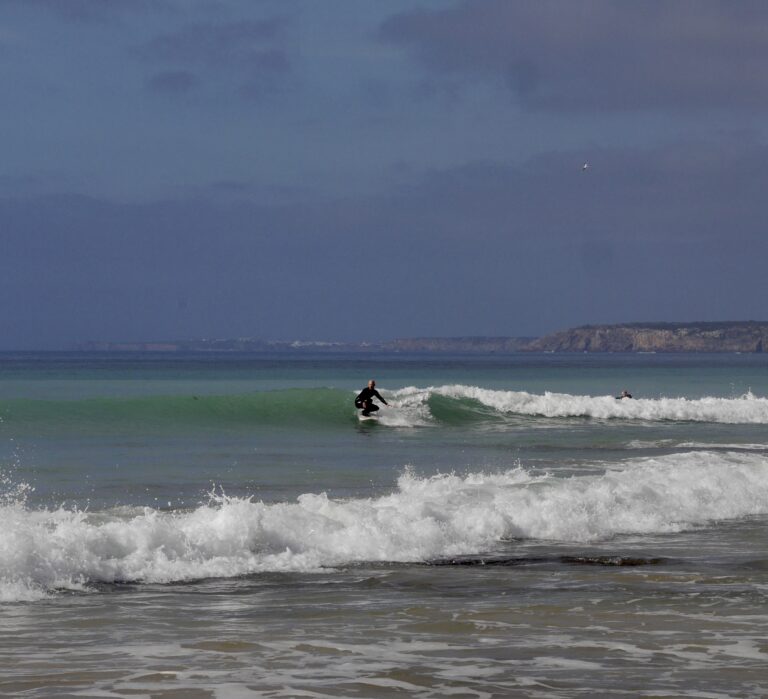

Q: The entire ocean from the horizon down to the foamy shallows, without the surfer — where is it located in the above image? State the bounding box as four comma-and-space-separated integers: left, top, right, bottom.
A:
0, 353, 768, 699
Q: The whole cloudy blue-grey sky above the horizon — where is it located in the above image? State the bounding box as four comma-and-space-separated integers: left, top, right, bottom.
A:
0, 0, 768, 350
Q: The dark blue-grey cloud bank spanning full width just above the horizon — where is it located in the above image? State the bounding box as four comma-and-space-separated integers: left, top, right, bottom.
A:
0, 134, 768, 347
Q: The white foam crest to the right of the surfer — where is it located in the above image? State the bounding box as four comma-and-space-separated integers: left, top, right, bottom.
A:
394, 385, 768, 424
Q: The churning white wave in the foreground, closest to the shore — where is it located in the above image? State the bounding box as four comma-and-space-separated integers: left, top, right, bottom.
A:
0, 452, 768, 601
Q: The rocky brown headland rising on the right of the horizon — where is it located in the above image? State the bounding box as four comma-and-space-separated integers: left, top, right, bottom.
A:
525, 321, 768, 352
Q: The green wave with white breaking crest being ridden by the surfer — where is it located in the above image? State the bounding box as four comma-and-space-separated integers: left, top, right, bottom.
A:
0, 385, 768, 434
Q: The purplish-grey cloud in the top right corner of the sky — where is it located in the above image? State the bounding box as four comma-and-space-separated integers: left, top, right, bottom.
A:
379, 0, 768, 111
